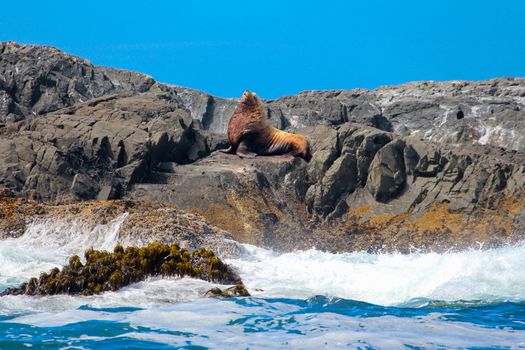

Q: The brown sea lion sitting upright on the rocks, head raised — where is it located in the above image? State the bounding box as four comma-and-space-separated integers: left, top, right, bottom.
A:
221, 90, 312, 161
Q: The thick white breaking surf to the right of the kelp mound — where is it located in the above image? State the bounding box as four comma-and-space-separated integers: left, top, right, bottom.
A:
227, 244, 525, 305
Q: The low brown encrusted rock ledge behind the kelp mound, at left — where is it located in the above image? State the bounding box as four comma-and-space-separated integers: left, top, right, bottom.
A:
0, 196, 242, 258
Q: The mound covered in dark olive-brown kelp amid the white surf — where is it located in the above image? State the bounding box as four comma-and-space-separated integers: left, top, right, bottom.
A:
0, 243, 242, 296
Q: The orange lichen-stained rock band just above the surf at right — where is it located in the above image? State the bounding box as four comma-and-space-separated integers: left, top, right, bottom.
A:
333, 195, 524, 253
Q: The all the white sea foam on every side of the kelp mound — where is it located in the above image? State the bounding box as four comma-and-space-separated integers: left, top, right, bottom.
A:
0, 216, 525, 310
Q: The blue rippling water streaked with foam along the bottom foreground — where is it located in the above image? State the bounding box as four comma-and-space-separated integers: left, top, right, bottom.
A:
0, 296, 525, 349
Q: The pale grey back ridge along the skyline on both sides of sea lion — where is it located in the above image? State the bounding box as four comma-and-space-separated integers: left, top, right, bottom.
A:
4, 42, 525, 150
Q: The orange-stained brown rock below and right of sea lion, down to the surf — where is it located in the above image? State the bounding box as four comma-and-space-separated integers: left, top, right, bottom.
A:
129, 123, 525, 251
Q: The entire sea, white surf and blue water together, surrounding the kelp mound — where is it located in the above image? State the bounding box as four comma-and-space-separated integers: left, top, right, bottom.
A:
0, 215, 525, 349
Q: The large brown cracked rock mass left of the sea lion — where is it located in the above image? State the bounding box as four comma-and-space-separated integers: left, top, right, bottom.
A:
0, 93, 209, 199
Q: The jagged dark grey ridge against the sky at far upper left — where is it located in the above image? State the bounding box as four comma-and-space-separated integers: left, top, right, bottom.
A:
0, 42, 155, 123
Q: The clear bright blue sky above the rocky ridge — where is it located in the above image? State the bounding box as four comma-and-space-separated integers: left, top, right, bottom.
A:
0, 0, 525, 98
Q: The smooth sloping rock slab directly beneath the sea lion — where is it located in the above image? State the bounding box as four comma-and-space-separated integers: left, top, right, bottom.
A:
129, 152, 308, 249
